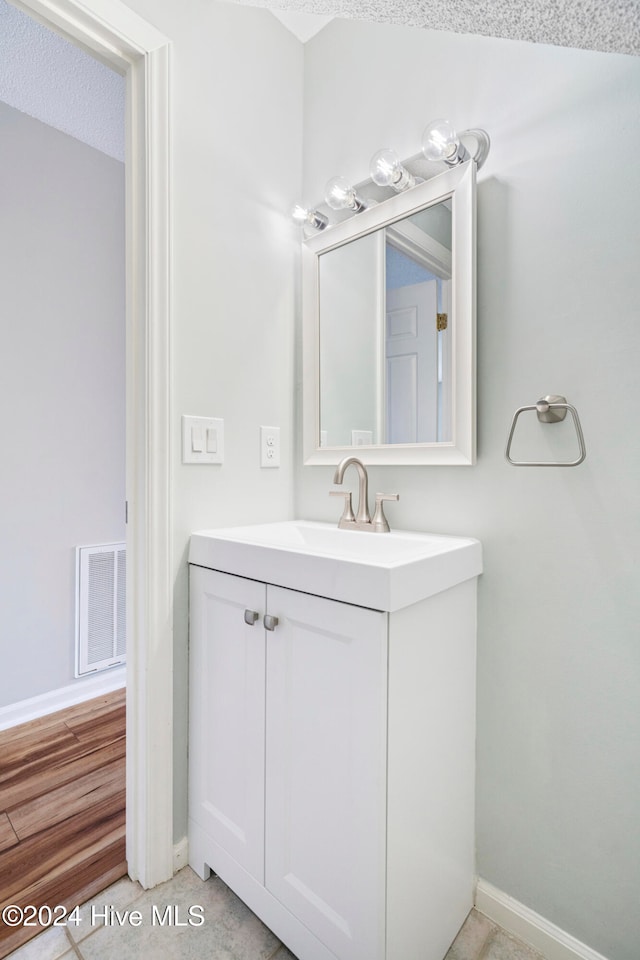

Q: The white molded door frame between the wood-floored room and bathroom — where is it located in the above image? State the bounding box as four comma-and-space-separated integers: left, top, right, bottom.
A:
11, 0, 174, 888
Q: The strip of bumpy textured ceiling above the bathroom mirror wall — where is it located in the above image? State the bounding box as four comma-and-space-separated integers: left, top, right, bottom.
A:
242, 0, 640, 55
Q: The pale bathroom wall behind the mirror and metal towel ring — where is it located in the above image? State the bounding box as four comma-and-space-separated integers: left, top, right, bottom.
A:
297, 21, 640, 960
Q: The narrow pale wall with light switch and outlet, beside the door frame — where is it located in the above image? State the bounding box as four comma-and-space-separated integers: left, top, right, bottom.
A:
115, 0, 302, 840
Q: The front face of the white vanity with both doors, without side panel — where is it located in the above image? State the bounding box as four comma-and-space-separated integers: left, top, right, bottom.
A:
189, 567, 387, 960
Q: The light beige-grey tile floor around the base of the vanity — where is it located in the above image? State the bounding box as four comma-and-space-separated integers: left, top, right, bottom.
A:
6, 867, 544, 960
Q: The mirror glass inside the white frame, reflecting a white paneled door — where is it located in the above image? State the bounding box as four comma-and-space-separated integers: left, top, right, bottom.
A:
318, 199, 453, 447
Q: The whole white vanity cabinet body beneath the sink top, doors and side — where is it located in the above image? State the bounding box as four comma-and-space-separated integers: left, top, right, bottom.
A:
189, 532, 476, 960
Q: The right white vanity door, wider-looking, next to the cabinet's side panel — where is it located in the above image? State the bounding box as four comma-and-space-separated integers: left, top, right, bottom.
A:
265, 587, 387, 960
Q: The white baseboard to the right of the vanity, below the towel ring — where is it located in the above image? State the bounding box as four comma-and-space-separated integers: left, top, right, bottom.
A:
476, 878, 606, 960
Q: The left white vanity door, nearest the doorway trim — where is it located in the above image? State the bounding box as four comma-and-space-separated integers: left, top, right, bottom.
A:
189, 566, 266, 883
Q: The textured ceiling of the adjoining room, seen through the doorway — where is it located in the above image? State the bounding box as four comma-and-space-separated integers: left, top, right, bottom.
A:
0, 0, 125, 160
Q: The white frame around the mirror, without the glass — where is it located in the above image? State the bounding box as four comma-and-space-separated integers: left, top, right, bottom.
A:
302, 160, 476, 466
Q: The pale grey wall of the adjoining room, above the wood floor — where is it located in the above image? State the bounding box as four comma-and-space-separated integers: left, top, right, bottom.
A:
0, 103, 125, 707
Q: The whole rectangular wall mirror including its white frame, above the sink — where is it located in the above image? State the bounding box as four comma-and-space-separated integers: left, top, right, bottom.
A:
303, 161, 475, 465
